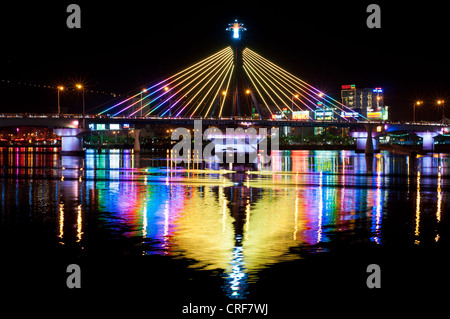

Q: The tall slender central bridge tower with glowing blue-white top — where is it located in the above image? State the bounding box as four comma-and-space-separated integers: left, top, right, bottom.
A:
226, 19, 247, 116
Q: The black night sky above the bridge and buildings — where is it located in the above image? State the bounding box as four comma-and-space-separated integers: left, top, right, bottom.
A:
0, 0, 450, 120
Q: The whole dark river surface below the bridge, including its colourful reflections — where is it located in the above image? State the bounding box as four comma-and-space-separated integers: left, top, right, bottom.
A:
0, 148, 450, 318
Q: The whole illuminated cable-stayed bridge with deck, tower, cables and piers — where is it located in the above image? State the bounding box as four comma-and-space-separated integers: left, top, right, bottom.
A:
0, 21, 449, 154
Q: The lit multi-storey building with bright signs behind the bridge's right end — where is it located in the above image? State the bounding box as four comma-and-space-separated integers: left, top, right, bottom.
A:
341, 84, 388, 120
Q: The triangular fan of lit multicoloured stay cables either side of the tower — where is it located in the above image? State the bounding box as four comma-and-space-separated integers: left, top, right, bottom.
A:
98, 47, 367, 122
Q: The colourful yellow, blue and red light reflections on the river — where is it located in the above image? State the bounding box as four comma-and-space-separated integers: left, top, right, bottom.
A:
0, 149, 450, 298
